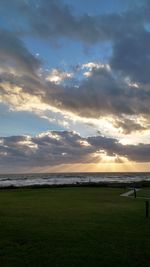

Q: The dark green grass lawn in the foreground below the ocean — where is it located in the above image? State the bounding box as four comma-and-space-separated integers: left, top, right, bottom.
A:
0, 187, 150, 267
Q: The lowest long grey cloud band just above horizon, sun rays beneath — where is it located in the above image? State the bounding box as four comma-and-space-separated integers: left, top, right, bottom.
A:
0, 131, 150, 171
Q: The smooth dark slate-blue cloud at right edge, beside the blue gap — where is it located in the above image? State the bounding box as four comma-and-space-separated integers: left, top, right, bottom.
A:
110, 30, 150, 84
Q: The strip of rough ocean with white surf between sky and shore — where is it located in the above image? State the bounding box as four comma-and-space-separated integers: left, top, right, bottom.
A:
0, 173, 150, 187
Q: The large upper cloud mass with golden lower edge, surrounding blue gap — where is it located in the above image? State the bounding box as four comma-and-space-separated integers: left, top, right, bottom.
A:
0, 0, 150, 133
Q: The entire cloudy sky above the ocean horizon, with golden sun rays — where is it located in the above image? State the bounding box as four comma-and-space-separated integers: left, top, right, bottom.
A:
0, 0, 150, 173
